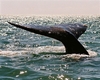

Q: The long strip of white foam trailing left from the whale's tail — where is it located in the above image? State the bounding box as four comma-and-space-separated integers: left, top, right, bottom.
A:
0, 46, 65, 56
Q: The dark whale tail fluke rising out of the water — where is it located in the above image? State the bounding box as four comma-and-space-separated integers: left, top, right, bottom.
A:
8, 22, 89, 55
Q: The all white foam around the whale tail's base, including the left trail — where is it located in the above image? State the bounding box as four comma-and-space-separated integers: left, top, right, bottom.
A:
0, 46, 97, 59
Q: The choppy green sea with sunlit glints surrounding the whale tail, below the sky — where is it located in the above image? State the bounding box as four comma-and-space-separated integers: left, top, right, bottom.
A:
0, 16, 100, 80
